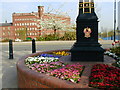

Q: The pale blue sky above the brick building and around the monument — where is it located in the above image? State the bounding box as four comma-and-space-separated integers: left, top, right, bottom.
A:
0, 0, 120, 32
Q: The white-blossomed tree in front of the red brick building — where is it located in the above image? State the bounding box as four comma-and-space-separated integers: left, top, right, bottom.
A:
38, 4, 74, 35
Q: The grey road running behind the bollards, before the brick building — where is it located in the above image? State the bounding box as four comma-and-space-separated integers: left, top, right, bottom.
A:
2, 41, 112, 51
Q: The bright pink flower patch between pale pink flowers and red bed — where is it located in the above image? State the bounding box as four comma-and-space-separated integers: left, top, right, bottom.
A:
48, 64, 84, 83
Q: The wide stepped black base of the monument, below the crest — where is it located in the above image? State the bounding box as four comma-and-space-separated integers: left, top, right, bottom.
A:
70, 43, 104, 62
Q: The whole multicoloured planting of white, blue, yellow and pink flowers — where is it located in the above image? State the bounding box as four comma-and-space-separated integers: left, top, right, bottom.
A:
25, 51, 84, 83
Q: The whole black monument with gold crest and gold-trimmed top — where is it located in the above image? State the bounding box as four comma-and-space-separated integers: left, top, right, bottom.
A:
70, 0, 104, 62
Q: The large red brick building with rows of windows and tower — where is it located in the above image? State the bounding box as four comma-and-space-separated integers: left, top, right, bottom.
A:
0, 6, 70, 39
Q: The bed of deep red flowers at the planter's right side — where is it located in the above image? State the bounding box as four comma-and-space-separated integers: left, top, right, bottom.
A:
89, 64, 120, 90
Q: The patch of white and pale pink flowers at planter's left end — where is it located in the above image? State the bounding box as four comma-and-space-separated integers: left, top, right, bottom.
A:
25, 57, 65, 73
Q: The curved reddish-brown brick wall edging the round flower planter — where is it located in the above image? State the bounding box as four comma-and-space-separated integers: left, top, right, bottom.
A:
17, 50, 87, 88
